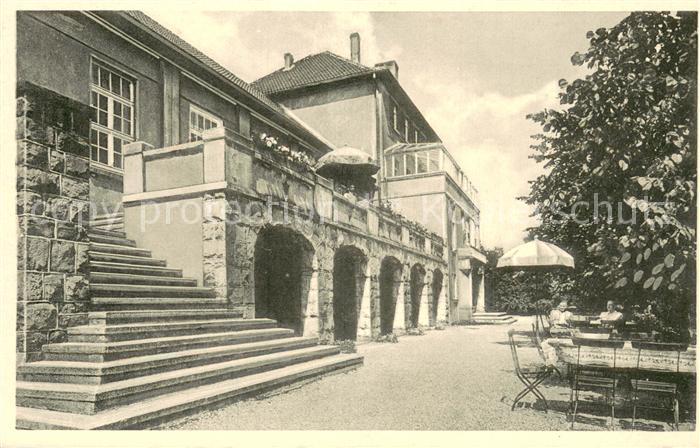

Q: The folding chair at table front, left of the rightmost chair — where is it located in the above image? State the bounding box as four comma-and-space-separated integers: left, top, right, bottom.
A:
569, 337, 625, 430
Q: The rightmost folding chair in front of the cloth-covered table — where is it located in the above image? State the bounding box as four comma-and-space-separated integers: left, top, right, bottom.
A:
631, 341, 688, 431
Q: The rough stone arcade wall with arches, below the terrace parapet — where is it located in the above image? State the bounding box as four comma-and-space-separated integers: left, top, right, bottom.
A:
219, 189, 447, 341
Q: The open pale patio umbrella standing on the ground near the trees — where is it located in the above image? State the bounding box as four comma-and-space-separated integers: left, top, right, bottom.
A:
496, 237, 574, 314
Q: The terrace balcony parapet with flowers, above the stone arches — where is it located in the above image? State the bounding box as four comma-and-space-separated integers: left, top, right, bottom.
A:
123, 128, 444, 258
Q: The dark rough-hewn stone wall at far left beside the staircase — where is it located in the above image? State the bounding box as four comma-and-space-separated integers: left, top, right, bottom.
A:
16, 83, 90, 362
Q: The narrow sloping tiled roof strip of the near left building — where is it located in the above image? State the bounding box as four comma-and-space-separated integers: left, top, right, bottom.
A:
125, 11, 282, 112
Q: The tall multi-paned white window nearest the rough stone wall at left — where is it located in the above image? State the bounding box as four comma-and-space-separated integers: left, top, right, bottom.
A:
90, 62, 135, 169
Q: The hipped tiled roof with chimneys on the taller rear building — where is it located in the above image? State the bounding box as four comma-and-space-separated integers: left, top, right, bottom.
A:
252, 51, 374, 94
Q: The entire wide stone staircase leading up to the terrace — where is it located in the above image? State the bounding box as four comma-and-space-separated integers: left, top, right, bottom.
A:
16, 226, 362, 429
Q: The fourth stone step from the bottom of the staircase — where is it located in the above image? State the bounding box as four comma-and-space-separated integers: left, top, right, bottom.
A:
42, 328, 294, 362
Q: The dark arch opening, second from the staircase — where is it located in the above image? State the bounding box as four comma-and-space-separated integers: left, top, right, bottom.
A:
333, 246, 367, 340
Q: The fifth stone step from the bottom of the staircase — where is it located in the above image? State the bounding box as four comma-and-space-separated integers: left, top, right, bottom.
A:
66, 318, 276, 342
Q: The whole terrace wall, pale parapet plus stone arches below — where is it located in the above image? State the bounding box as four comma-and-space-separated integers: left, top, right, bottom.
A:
123, 128, 448, 341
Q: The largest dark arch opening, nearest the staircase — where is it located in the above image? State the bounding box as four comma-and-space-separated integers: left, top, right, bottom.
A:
253, 225, 316, 335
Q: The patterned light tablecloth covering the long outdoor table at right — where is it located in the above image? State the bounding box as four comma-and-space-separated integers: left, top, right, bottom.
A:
542, 338, 696, 373
